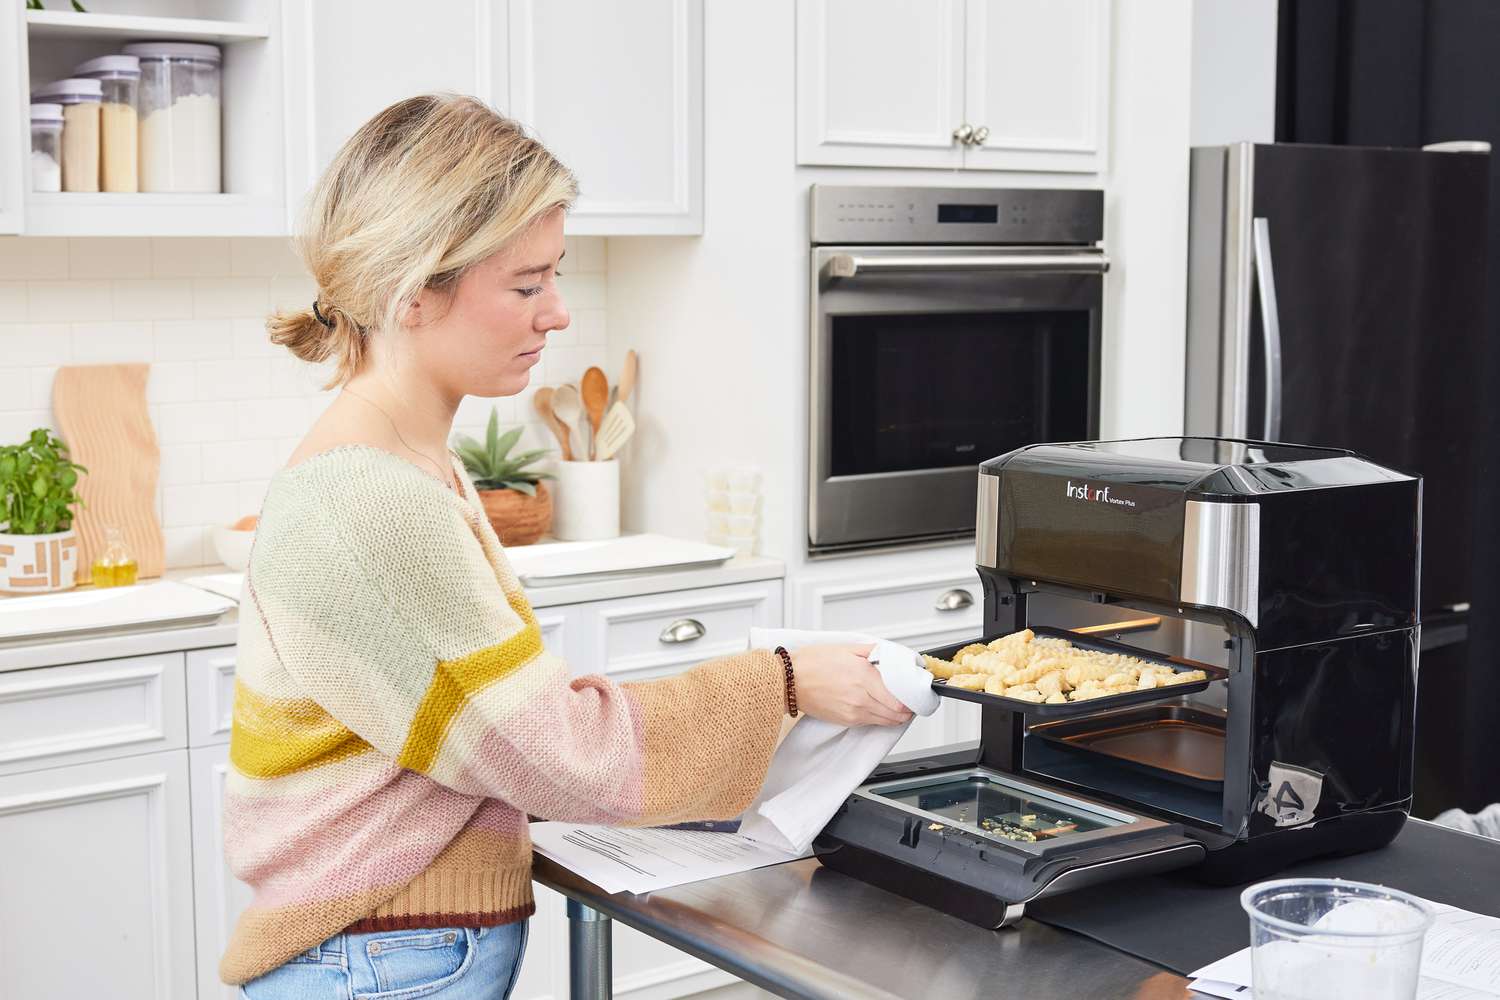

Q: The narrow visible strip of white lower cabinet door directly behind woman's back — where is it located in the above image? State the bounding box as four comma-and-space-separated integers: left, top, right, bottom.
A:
188, 744, 251, 1000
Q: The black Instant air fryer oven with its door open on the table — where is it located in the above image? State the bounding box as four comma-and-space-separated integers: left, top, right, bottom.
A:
815, 438, 1422, 927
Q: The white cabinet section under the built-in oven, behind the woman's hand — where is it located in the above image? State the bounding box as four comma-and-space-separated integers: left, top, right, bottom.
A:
788, 546, 984, 753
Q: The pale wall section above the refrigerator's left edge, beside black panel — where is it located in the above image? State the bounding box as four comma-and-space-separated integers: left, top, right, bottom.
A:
1190, 0, 1277, 145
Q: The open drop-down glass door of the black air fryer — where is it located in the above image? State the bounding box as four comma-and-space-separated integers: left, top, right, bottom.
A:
813, 766, 1205, 928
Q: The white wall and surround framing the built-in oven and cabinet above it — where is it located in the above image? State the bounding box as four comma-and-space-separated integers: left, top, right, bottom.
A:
609, 0, 1193, 565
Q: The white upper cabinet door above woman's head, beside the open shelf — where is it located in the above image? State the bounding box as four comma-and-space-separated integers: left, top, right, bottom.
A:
287, 0, 506, 200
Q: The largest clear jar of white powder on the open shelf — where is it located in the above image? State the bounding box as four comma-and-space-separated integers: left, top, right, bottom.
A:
125, 42, 224, 192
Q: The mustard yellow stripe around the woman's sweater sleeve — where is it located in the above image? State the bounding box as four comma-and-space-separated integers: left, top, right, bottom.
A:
396, 592, 542, 774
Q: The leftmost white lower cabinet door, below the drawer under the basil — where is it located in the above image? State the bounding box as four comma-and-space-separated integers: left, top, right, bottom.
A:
0, 750, 195, 1000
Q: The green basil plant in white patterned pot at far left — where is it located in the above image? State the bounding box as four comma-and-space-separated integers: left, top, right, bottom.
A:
0, 427, 87, 595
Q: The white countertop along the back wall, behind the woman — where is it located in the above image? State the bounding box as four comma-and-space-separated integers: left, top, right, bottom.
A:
0, 556, 786, 673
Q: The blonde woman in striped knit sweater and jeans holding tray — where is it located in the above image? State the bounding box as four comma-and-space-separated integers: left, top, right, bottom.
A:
221, 96, 911, 1000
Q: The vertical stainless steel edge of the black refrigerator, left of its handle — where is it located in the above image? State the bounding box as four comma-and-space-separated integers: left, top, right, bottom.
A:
1218, 142, 1256, 438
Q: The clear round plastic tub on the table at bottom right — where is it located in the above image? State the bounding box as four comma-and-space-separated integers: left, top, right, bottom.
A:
1239, 879, 1434, 1000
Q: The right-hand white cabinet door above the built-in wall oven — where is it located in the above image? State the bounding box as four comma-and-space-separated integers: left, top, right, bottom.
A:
965, 0, 1110, 171
